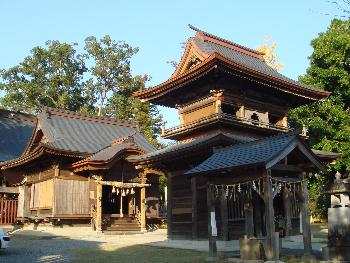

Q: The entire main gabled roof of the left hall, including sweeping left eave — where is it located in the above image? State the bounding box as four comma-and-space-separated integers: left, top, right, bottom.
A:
3, 108, 155, 170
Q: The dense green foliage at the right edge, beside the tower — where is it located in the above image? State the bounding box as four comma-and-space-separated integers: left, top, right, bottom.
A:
289, 19, 350, 219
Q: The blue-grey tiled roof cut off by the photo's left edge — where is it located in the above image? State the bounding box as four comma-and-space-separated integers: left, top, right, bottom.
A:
0, 110, 35, 162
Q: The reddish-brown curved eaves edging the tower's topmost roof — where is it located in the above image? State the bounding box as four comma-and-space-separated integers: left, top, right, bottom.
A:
133, 53, 331, 106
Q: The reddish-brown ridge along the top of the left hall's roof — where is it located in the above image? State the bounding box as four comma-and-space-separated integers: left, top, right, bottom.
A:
42, 107, 140, 130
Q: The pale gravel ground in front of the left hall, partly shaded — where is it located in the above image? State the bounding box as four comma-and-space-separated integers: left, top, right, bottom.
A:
0, 228, 166, 263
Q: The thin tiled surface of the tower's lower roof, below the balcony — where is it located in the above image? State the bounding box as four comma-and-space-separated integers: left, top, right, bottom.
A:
128, 132, 255, 164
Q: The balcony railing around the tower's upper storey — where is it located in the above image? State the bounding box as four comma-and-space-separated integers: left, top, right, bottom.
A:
162, 113, 292, 137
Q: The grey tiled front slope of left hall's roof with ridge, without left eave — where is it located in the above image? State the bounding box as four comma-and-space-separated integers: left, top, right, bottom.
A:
38, 108, 154, 154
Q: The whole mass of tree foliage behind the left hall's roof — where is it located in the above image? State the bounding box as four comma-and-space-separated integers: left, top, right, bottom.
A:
0, 36, 162, 146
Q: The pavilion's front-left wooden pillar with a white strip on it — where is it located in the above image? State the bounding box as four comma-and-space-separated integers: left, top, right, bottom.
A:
207, 185, 217, 261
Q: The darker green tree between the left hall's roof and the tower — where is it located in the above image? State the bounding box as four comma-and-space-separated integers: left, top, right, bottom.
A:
105, 75, 163, 147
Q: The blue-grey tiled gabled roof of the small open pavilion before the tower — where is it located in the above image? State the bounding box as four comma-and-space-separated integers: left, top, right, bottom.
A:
186, 131, 324, 175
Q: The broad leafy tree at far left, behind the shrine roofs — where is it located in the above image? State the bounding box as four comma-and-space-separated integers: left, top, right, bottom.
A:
0, 41, 88, 111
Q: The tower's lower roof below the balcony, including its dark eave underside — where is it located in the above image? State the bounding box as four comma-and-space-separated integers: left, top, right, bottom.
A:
128, 132, 255, 163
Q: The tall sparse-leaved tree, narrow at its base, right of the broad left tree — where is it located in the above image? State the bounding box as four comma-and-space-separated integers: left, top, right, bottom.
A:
85, 35, 138, 116
